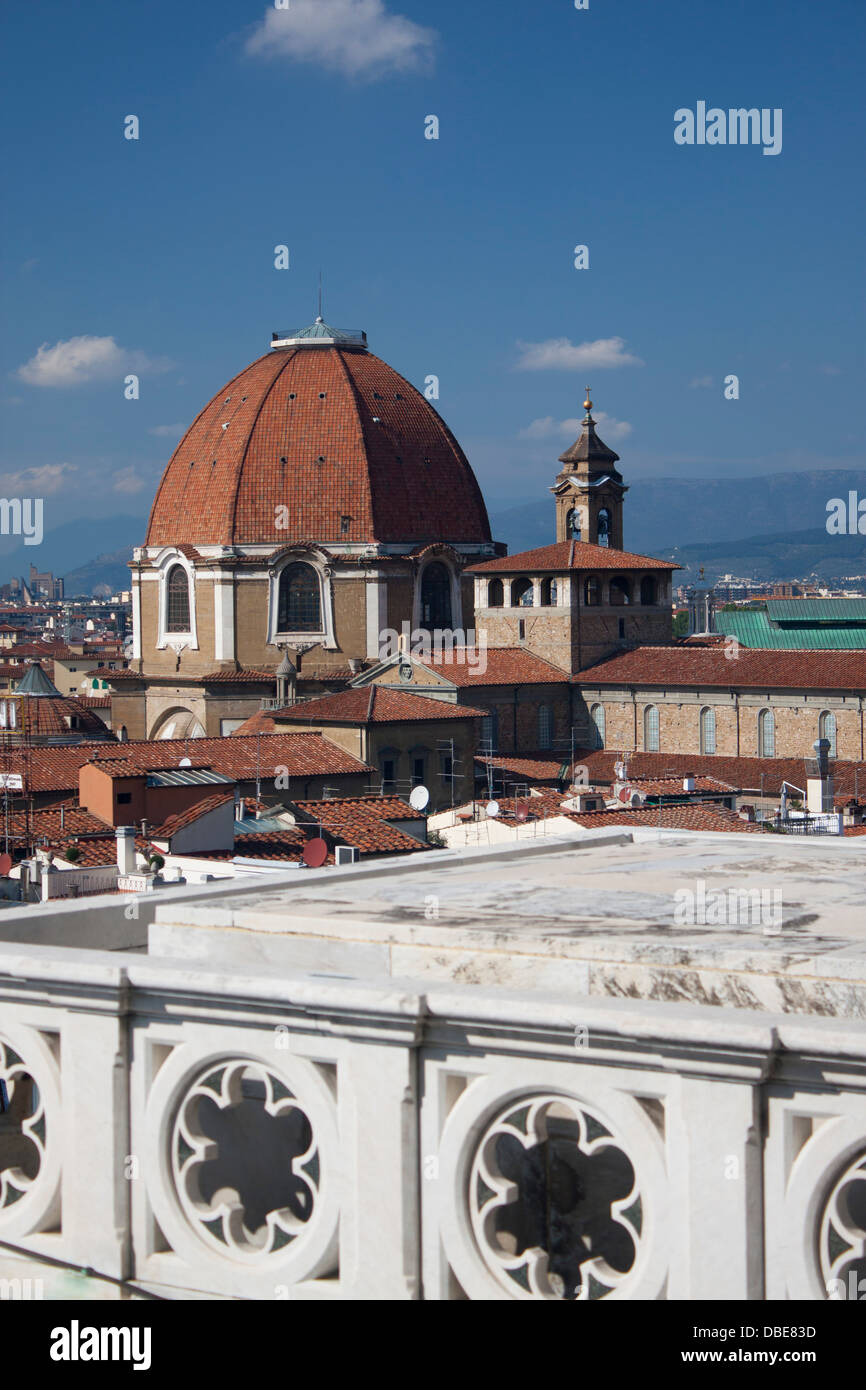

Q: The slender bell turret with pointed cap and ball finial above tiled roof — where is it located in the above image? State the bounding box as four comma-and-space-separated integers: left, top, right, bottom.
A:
550, 386, 628, 550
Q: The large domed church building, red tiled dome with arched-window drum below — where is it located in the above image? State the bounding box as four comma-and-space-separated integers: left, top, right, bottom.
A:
113, 316, 505, 738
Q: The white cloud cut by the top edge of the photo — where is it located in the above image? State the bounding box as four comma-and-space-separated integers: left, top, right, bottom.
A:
246, 0, 436, 79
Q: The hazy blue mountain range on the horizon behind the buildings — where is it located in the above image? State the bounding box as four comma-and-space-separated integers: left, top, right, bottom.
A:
0, 468, 866, 595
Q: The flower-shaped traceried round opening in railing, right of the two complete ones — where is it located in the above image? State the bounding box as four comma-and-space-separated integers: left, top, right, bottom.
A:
468, 1095, 644, 1302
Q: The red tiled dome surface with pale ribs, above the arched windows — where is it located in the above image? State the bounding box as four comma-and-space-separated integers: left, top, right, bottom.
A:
146, 325, 491, 546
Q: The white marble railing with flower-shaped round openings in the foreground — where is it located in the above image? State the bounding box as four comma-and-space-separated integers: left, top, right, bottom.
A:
0, 944, 866, 1300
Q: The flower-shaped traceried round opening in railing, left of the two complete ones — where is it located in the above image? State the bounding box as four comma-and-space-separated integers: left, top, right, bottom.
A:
171, 1059, 320, 1258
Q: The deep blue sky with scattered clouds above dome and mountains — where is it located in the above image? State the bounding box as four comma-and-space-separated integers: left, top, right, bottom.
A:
0, 0, 866, 553
